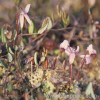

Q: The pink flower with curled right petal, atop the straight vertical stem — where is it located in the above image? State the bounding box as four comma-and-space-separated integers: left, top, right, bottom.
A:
65, 46, 79, 64
